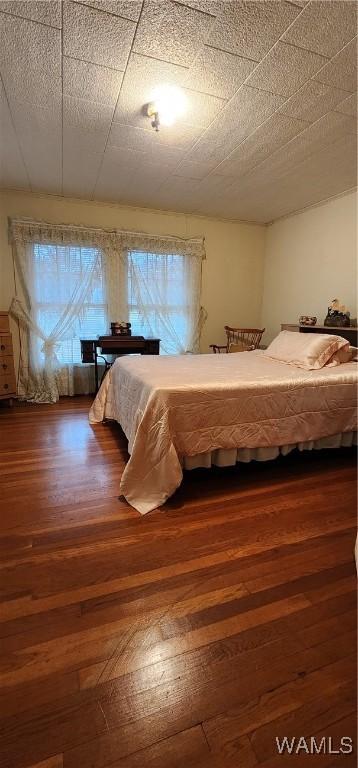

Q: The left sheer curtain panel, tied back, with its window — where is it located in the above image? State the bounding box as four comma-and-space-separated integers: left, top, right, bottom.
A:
10, 223, 116, 403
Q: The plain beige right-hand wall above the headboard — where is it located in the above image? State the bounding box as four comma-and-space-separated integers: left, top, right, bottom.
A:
261, 192, 357, 343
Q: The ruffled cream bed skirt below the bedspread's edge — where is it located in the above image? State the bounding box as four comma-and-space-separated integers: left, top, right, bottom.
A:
182, 432, 358, 469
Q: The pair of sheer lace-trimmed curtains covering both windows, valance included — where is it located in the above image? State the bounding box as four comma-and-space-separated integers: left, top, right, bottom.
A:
10, 220, 205, 402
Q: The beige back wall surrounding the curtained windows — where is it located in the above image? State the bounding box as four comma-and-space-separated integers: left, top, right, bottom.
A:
0, 192, 265, 370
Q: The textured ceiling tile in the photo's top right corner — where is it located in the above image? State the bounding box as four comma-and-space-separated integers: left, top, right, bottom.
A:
282, 0, 357, 58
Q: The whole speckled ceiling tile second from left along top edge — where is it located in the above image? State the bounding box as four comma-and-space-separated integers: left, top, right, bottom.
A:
63, 2, 136, 71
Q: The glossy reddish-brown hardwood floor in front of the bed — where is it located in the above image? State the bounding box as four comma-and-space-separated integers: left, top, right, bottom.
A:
0, 398, 356, 768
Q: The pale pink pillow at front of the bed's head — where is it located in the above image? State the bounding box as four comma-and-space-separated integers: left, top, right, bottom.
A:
263, 331, 349, 371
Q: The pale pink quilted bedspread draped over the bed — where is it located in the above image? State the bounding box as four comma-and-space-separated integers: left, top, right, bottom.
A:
90, 350, 357, 514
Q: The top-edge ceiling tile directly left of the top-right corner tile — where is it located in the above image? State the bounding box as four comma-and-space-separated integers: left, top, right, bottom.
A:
207, 0, 301, 61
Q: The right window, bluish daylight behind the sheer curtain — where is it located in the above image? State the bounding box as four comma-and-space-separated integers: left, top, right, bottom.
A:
127, 251, 192, 354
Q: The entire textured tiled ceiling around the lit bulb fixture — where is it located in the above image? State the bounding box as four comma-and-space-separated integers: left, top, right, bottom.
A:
0, 0, 356, 221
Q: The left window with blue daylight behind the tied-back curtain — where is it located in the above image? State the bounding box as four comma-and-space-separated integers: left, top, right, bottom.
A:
31, 243, 108, 365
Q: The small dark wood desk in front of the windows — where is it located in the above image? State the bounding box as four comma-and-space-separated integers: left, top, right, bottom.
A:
80, 336, 160, 392
